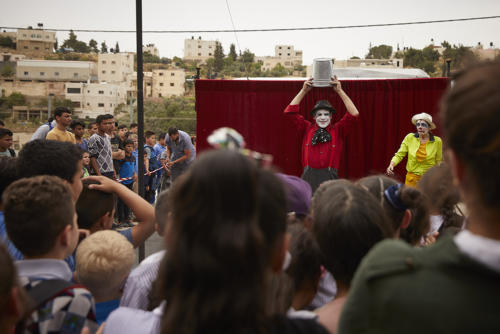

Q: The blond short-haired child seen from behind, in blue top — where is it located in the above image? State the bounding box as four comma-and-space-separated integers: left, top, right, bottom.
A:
75, 231, 134, 325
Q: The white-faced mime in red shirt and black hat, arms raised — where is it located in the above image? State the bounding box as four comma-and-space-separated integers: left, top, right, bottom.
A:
285, 76, 359, 192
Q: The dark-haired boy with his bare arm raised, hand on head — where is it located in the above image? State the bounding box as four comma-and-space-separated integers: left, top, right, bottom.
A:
76, 176, 154, 247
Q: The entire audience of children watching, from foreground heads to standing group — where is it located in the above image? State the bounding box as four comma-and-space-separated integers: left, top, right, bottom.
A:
0, 62, 500, 334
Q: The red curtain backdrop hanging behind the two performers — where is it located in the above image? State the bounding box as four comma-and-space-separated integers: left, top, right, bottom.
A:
196, 78, 448, 179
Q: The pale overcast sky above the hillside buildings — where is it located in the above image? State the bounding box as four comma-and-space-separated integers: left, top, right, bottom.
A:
0, 0, 500, 64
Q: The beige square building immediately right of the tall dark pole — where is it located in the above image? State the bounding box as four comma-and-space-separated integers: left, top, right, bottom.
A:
152, 69, 186, 97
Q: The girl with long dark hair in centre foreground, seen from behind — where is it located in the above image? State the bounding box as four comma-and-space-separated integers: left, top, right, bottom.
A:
105, 150, 327, 334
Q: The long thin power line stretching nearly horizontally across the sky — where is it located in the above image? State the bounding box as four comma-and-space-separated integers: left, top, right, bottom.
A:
0, 15, 500, 34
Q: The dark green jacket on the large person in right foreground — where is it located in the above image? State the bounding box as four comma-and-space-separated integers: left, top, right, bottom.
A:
339, 237, 500, 334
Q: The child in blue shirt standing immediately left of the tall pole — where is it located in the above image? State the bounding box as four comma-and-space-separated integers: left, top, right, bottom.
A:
116, 139, 137, 227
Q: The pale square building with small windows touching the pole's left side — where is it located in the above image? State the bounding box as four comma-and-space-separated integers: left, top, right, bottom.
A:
97, 52, 134, 82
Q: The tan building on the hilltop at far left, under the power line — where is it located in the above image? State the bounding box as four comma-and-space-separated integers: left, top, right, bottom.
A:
16, 29, 56, 55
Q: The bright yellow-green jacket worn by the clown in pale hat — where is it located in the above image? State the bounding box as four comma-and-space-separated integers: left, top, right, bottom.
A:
391, 133, 443, 175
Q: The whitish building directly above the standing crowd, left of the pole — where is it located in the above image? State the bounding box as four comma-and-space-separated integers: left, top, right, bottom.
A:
65, 82, 127, 118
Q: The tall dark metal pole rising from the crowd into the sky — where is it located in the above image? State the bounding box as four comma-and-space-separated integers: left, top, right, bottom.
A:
135, 0, 145, 262
